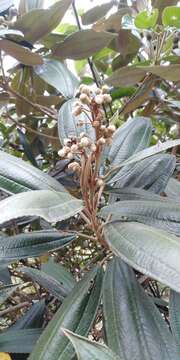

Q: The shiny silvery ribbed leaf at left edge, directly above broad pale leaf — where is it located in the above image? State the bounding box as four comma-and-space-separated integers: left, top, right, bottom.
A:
0, 151, 66, 193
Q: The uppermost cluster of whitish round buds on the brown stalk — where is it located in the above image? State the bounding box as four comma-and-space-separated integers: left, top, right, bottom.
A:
73, 85, 112, 116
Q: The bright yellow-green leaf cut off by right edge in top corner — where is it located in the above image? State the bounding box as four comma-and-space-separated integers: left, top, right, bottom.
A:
162, 6, 180, 29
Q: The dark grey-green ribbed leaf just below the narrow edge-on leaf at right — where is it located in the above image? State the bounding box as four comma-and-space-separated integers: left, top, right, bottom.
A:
109, 154, 176, 194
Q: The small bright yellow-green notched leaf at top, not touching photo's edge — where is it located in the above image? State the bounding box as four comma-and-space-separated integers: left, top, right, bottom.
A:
134, 9, 159, 29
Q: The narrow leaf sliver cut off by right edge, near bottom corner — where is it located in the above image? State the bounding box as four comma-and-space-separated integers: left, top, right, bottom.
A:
169, 290, 180, 355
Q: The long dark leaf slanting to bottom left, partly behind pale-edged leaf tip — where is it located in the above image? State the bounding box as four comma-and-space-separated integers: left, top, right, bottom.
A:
29, 268, 102, 360
